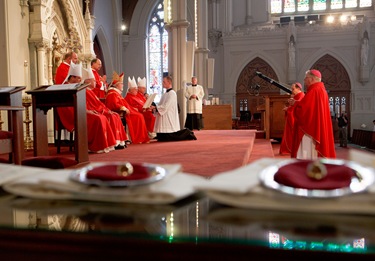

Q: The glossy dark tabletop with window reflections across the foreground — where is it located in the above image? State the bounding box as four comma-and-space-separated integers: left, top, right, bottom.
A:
1, 196, 375, 260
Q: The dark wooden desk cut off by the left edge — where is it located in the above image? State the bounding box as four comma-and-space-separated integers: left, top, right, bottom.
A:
0, 106, 25, 162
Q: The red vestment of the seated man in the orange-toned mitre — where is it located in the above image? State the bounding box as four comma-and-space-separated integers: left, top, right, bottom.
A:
105, 88, 150, 144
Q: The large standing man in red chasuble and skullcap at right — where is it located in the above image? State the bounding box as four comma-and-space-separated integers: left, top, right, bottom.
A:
291, 69, 336, 159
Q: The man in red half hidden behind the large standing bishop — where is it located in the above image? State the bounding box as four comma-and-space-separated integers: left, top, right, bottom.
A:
279, 82, 305, 155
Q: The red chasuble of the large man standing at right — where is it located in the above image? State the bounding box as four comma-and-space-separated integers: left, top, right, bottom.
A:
291, 82, 336, 158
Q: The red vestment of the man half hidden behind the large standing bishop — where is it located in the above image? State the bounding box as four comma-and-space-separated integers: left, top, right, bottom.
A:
279, 92, 305, 155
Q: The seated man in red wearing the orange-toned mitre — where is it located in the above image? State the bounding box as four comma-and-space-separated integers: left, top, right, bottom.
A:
105, 72, 150, 144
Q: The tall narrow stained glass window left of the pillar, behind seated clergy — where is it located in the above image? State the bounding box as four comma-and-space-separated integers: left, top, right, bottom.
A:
147, 1, 168, 103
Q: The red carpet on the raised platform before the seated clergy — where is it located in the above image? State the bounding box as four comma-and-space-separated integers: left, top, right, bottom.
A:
13, 130, 258, 176
